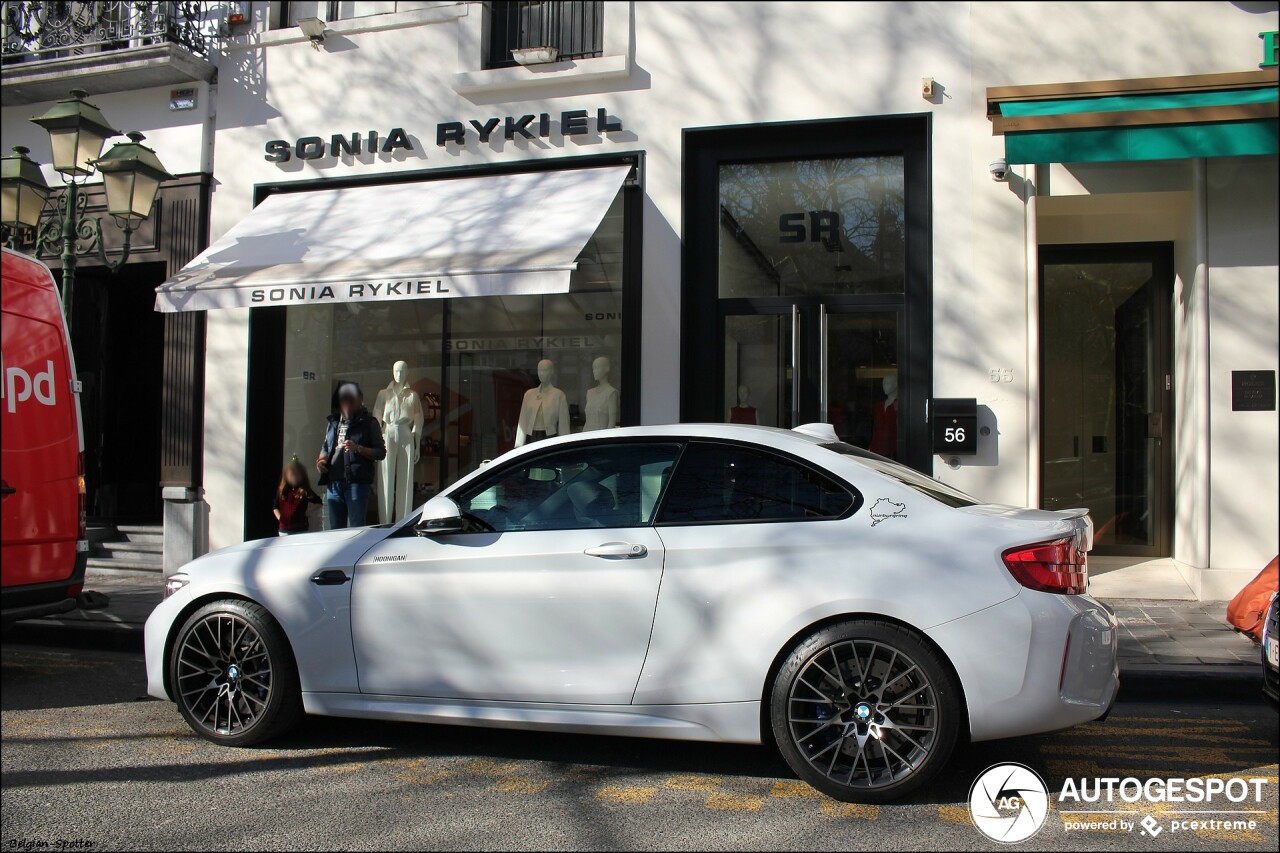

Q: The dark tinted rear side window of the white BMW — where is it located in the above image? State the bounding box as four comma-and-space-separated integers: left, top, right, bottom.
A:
658, 442, 856, 525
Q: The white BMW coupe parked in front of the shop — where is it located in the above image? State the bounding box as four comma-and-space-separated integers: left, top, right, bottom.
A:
146, 424, 1119, 802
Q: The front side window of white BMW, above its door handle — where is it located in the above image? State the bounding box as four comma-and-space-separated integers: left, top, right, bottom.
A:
452, 442, 682, 533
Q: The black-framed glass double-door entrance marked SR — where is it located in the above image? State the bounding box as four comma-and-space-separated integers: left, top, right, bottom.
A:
682, 119, 932, 473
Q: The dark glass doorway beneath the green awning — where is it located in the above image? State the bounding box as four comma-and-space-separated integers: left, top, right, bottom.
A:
1039, 243, 1172, 557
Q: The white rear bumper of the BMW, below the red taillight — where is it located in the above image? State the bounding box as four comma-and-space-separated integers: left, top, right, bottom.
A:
928, 589, 1120, 740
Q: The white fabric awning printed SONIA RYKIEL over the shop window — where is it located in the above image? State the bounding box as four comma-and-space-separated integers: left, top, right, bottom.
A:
156, 165, 630, 311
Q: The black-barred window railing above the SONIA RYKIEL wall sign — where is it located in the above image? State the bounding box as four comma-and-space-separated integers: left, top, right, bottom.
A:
485, 0, 604, 68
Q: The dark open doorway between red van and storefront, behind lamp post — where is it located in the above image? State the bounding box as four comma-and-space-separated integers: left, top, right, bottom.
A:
72, 263, 166, 524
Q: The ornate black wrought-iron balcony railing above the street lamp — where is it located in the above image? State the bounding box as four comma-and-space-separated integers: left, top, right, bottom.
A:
0, 0, 216, 64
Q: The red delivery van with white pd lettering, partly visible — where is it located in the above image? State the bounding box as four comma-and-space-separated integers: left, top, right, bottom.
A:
0, 248, 88, 625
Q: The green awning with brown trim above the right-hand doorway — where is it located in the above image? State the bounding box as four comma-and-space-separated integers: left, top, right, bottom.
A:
987, 70, 1280, 163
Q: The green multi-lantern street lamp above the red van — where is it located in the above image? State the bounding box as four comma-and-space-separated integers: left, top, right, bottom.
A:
0, 90, 173, 328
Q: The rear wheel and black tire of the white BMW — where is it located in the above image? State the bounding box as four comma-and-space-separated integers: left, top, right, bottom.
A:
769, 620, 964, 803
